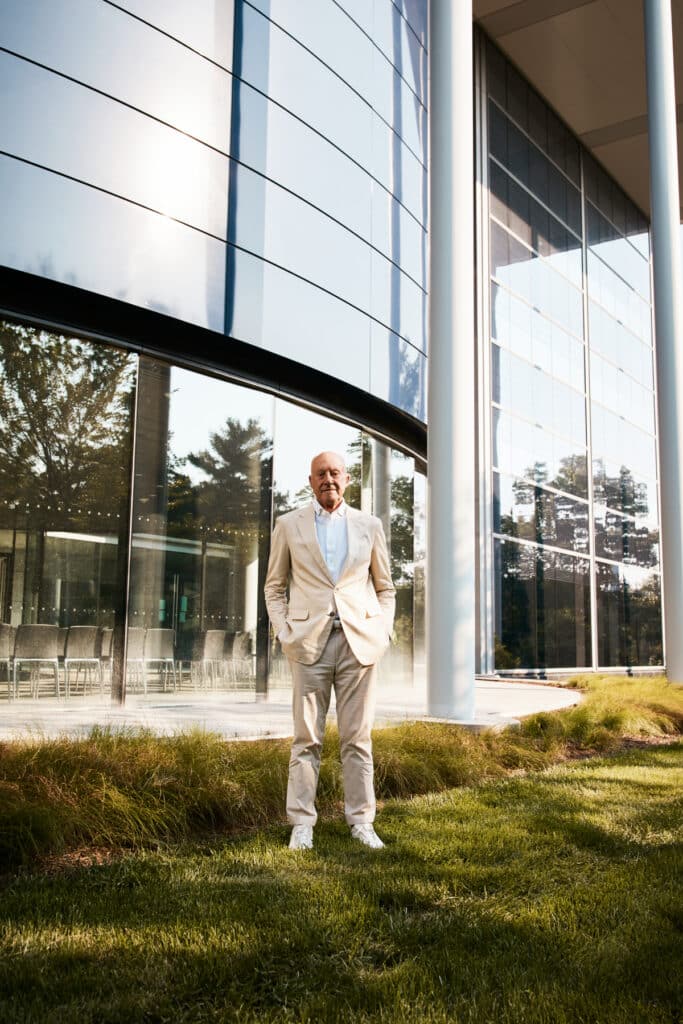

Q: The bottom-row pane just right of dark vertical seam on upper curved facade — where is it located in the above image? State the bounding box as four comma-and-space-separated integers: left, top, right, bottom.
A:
226, 246, 371, 391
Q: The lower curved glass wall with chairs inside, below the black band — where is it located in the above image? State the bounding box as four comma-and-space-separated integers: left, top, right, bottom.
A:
0, 322, 425, 701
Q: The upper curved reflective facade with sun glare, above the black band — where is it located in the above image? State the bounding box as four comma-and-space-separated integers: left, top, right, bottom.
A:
0, 0, 427, 419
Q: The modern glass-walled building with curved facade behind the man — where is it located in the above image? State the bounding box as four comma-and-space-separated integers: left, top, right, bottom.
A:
0, 0, 683, 713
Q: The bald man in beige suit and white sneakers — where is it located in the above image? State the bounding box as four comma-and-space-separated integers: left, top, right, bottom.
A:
265, 452, 395, 850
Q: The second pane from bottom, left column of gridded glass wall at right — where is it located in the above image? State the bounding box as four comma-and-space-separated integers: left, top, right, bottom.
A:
494, 473, 589, 553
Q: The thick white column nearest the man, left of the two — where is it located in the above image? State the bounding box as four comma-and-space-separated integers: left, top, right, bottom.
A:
427, 0, 476, 721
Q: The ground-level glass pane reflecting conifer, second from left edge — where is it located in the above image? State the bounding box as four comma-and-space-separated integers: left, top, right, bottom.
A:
128, 358, 273, 693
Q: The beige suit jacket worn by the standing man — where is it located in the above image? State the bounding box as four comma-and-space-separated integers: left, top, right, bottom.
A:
264, 505, 395, 665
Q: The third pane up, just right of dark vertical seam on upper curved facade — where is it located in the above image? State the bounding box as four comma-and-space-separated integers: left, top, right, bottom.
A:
234, 82, 374, 240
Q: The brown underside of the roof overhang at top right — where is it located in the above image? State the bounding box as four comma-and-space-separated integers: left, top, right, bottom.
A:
472, 0, 683, 220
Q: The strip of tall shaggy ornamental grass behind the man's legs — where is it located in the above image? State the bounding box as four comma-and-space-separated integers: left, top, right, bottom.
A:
0, 676, 683, 871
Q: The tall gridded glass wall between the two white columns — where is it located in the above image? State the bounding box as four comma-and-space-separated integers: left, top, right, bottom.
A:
484, 37, 663, 670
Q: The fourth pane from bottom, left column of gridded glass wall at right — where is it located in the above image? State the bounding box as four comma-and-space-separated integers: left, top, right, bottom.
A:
492, 345, 587, 446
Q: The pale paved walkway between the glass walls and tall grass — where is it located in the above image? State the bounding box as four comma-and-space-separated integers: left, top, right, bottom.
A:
0, 680, 581, 739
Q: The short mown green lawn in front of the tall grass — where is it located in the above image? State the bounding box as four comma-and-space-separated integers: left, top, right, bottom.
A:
0, 745, 683, 1024
